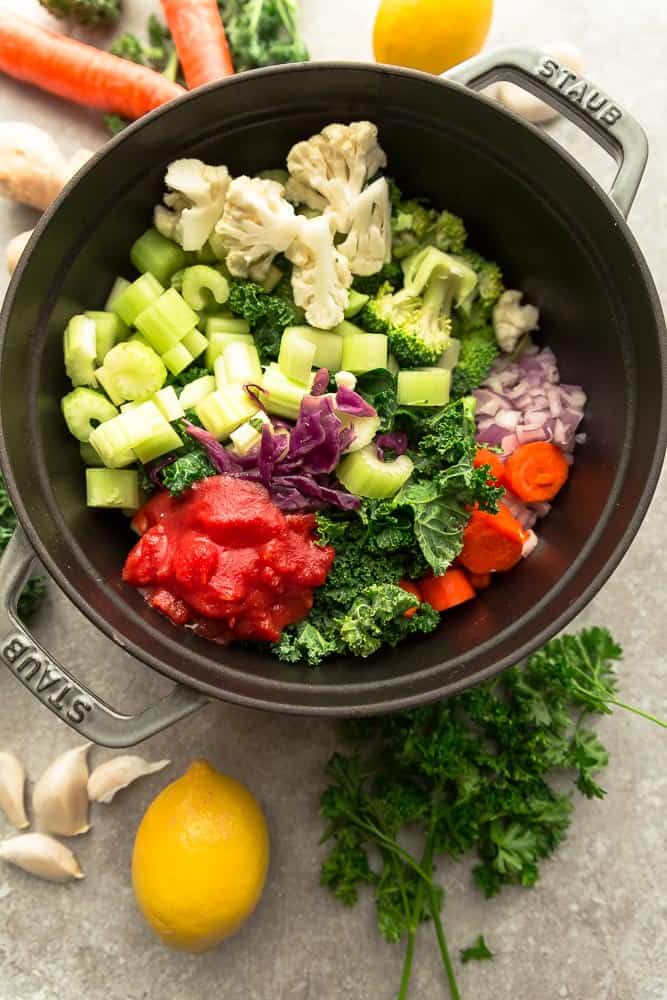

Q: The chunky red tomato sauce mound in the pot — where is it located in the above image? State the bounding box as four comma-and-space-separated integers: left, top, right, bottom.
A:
123, 476, 335, 642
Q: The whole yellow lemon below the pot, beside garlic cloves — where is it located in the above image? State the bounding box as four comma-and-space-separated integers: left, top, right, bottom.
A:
132, 760, 269, 952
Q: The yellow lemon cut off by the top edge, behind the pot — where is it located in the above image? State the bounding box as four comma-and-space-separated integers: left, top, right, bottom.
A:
373, 0, 493, 73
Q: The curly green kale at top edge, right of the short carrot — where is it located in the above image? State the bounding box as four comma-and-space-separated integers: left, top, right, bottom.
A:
218, 0, 308, 73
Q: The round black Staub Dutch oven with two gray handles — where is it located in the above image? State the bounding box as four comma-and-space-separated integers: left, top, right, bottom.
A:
0, 50, 665, 747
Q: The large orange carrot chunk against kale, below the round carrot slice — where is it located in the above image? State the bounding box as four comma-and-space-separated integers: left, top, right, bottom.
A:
459, 504, 528, 573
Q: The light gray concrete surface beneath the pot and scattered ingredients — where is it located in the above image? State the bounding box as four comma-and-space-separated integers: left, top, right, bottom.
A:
0, 0, 667, 1000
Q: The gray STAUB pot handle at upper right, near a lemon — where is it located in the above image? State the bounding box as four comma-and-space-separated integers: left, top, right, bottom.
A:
444, 48, 648, 217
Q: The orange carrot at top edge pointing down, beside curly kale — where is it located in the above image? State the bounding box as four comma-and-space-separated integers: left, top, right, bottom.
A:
162, 0, 234, 90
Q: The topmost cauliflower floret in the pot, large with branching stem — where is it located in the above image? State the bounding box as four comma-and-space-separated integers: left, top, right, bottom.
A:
286, 122, 387, 233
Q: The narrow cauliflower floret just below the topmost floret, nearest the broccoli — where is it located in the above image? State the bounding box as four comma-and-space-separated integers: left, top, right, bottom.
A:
338, 177, 391, 275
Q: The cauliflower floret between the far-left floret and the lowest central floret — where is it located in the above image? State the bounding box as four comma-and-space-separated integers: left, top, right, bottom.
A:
215, 176, 303, 281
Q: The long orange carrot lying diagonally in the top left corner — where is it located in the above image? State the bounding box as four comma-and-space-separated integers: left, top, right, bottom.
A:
0, 14, 185, 118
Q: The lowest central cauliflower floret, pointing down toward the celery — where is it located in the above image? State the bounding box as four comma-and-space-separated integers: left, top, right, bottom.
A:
287, 213, 352, 330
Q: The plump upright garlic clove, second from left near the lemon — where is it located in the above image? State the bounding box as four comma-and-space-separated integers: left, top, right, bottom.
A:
32, 743, 90, 837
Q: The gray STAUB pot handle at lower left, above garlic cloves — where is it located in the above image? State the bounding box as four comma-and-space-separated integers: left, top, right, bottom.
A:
0, 528, 208, 749
